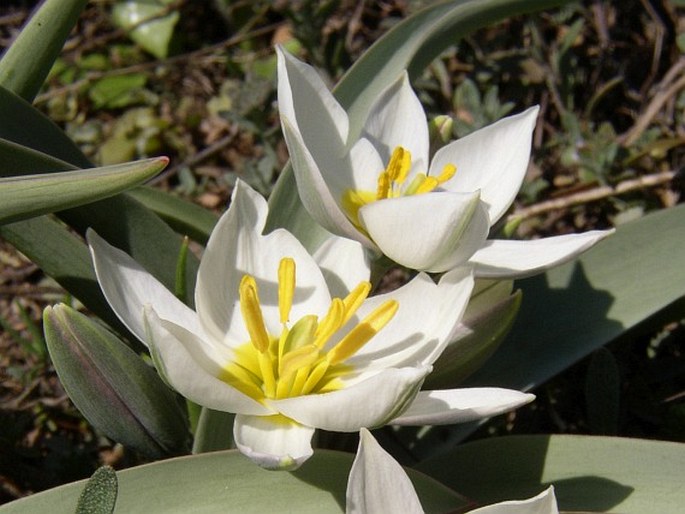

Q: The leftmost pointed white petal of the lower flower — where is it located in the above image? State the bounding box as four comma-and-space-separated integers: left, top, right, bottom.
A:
86, 229, 202, 345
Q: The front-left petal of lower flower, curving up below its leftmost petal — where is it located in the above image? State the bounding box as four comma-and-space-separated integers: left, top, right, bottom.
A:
146, 308, 273, 415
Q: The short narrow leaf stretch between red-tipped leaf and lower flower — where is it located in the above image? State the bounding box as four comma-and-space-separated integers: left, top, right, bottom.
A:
128, 186, 218, 244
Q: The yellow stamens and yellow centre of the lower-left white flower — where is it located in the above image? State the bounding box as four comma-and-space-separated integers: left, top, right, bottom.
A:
219, 257, 399, 402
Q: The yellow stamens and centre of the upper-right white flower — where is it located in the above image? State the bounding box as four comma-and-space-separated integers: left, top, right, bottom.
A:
342, 146, 457, 230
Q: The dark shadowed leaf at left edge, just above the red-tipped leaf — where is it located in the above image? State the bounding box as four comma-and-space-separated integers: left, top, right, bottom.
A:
0, 85, 92, 167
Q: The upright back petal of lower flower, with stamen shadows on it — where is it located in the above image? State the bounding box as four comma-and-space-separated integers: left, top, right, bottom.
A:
195, 181, 330, 346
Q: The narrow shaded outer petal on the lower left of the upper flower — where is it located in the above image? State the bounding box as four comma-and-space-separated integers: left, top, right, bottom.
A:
282, 119, 376, 250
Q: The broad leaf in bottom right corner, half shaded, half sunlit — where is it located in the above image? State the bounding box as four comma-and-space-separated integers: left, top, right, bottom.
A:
417, 435, 685, 514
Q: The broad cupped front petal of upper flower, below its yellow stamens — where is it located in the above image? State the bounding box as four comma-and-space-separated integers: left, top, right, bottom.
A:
359, 192, 489, 272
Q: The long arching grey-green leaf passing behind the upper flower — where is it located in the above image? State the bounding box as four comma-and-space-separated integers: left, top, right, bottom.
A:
267, 0, 565, 250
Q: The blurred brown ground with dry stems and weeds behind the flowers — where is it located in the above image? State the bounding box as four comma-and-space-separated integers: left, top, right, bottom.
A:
0, 0, 685, 502
